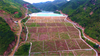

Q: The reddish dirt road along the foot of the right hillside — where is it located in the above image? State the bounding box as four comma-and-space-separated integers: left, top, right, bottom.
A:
59, 11, 100, 45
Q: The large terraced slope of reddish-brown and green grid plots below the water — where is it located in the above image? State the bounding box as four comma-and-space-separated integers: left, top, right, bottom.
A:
26, 16, 96, 56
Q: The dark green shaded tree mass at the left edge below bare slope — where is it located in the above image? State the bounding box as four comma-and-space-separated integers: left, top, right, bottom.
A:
0, 17, 15, 55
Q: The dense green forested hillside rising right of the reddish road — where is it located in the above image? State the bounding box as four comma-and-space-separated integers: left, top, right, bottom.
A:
61, 0, 100, 41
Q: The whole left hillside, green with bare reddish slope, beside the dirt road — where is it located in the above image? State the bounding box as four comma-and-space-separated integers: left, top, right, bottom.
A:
0, 0, 40, 56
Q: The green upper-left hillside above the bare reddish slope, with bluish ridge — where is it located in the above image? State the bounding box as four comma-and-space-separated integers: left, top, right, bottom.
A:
0, 0, 40, 18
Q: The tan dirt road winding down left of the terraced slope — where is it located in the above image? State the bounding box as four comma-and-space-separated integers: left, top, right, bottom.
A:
9, 9, 28, 56
